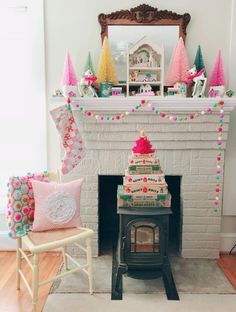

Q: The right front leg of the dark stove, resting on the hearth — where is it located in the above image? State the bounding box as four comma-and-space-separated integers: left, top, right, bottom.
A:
162, 263, 179, 300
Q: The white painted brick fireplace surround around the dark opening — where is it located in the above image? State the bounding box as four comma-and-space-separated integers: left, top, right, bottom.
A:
54, 98, 236, 258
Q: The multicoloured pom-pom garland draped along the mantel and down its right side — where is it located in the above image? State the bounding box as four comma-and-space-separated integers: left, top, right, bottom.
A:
67, 98, 224, 212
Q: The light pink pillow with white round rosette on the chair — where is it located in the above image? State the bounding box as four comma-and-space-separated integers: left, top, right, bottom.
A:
32, 179, 83, 232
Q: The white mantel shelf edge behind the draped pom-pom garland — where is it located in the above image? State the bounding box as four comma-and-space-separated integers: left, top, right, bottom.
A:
51, 96, 236, 113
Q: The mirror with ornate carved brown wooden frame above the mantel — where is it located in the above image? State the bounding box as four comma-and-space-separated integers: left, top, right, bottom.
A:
98, 4, 191, 81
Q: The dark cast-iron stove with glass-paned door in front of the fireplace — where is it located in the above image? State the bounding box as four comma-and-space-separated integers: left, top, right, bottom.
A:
111, 207, 179, 300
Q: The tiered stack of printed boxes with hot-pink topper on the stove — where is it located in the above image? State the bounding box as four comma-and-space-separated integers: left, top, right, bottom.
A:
117, 131, 171, 207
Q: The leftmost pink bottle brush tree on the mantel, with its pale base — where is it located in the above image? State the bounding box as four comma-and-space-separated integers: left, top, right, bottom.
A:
61, 52, 78, 97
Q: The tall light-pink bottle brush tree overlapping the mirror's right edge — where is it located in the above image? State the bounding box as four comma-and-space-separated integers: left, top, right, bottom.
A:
166, 37, 189, 86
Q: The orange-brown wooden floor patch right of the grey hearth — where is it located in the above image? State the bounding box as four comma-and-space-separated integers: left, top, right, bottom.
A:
217, 253, 236, 289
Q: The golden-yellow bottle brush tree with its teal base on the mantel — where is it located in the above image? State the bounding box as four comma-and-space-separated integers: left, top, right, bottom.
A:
97, 37, 118, 97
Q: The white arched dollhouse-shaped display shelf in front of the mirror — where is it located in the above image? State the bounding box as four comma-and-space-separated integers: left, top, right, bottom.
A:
127, 37, 164, 96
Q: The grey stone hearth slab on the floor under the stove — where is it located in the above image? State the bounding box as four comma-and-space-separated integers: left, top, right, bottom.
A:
50, 255, 236, 294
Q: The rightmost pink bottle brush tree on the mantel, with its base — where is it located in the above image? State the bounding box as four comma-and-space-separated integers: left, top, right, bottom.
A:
209, 50, 225, 97
